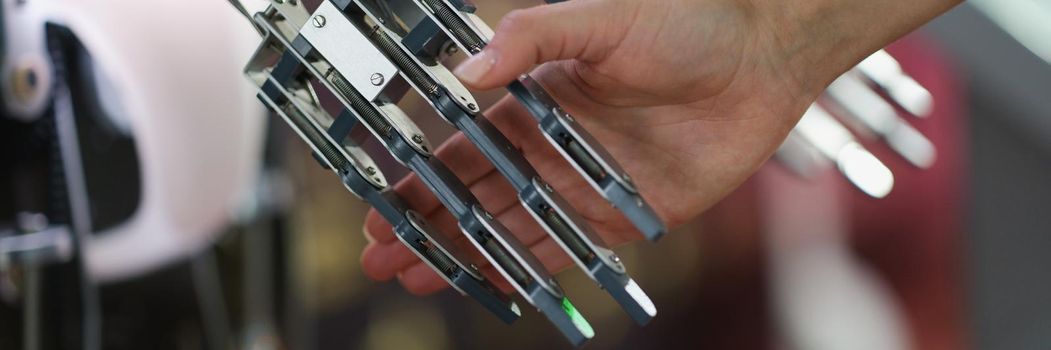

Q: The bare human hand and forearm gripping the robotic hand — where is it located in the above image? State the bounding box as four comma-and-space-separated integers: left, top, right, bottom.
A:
362, 0, 960, 294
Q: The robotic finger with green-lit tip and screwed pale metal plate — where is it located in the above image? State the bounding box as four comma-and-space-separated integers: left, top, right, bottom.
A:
242, 1, 594, 345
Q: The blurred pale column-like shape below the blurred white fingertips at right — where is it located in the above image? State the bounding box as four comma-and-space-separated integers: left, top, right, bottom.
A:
758, 168, 909, 350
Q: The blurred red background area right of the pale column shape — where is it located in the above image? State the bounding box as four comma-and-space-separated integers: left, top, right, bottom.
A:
850, 35, 968, 349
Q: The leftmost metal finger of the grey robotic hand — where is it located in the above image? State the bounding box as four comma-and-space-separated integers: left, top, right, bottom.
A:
246, 14, 520, 323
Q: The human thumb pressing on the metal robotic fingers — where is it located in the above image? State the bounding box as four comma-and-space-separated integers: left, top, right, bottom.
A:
454, 0, 631, 89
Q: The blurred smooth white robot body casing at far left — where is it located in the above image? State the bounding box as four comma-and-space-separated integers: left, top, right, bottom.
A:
2, 0, 265, 282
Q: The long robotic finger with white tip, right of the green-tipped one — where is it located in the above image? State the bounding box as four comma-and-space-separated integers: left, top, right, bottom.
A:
341, 0, 657, 325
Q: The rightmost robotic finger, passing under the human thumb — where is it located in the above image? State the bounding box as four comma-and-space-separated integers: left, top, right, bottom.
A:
399, 0, 667, 241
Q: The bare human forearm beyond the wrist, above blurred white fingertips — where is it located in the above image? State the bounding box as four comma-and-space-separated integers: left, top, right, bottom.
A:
757, 0, 962, 97
